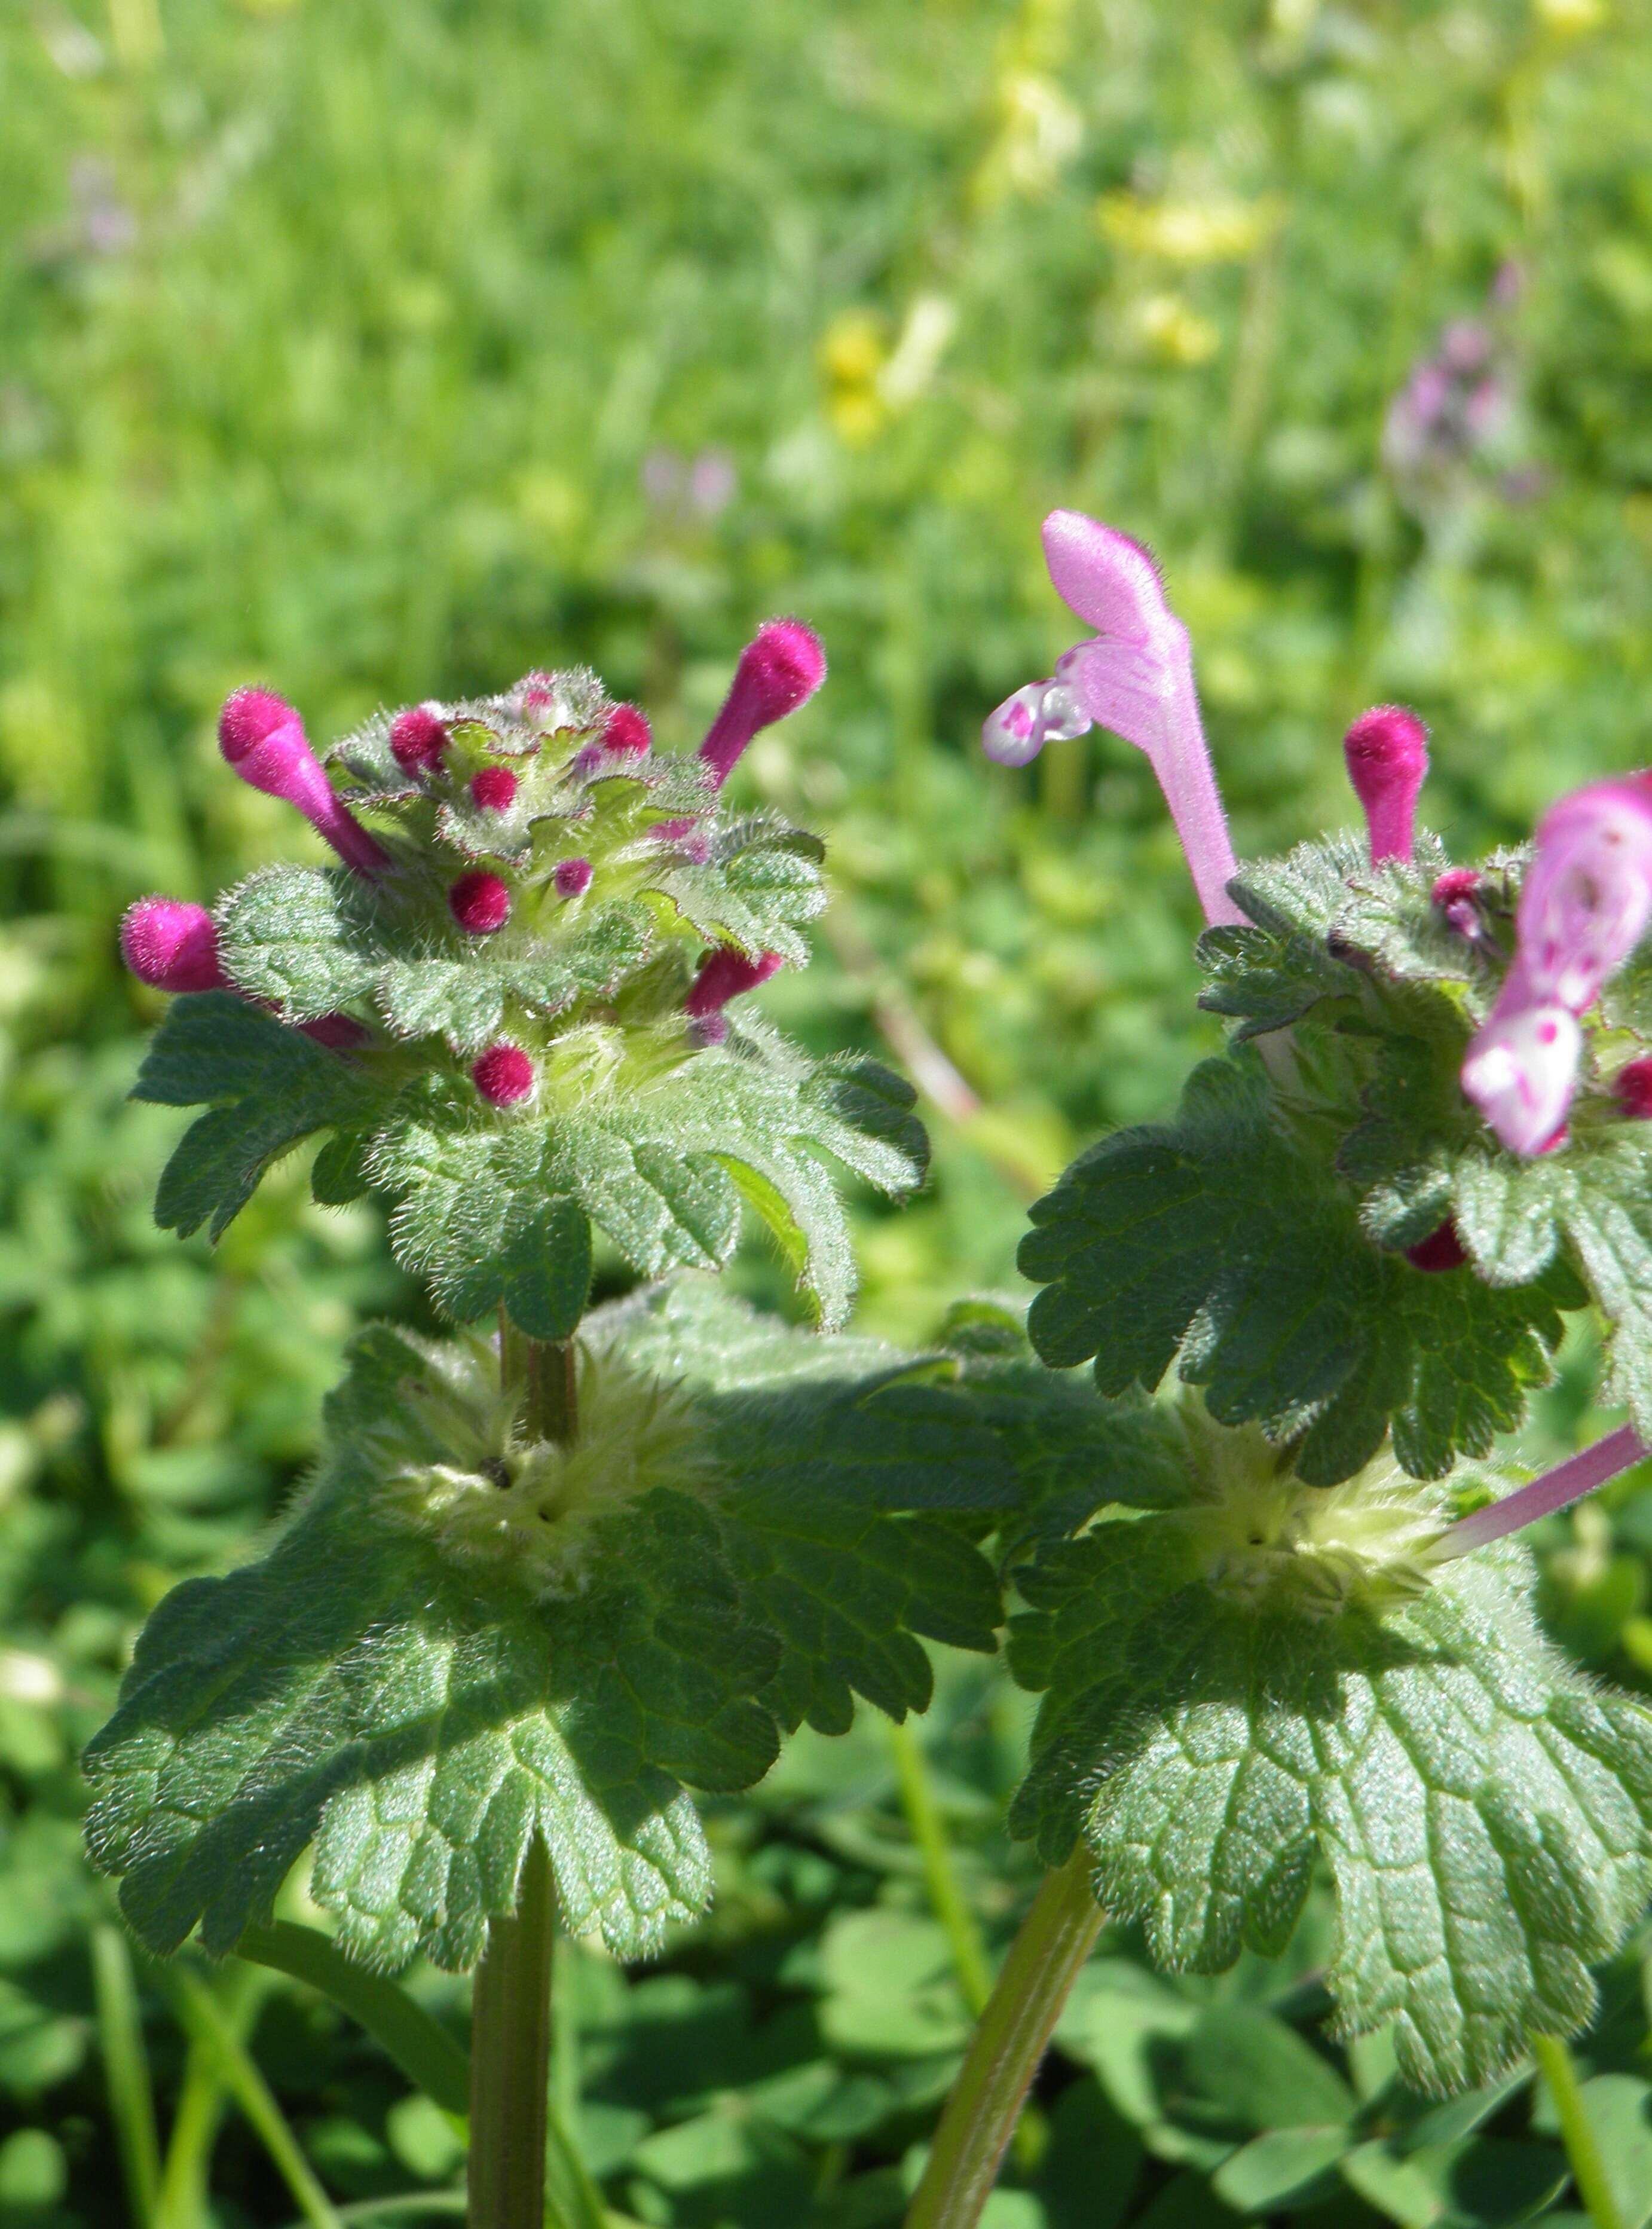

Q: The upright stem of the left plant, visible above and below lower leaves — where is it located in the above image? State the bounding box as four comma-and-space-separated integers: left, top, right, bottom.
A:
466, 1322, 577, 2229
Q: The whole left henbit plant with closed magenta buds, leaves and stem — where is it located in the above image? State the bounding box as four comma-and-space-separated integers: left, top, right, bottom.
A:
87, 622, 1030, 2229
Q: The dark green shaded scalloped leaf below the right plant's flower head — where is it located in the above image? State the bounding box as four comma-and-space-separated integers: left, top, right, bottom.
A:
1019, 1054, 1576, 1485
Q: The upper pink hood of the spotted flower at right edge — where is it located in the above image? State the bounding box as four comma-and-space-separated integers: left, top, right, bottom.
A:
1505, 780, 1652, 1014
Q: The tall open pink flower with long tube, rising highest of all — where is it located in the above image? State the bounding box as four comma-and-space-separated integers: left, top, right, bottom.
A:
981, 510, 1244, 925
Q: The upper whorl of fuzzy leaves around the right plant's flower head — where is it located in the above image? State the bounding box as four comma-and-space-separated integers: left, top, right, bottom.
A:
1021, 836, 1652, 1482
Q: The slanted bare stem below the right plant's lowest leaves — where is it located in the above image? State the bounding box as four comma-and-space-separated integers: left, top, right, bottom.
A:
905, 1843, 1103, 2229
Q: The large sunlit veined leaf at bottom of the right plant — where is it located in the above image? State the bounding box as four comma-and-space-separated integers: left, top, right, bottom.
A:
1010, 1516, 1652, 2091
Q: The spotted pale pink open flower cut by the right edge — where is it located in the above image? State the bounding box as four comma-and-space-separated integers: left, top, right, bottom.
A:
1463, 782, 1652, 1155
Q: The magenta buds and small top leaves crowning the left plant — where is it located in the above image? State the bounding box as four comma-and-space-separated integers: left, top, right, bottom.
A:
120, 620, 825, 1108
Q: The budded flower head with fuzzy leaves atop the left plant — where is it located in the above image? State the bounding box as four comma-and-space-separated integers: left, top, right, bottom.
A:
123, 620, 925, 1340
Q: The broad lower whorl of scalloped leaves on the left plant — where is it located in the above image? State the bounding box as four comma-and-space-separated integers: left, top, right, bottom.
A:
87, 1286, 1014, 1968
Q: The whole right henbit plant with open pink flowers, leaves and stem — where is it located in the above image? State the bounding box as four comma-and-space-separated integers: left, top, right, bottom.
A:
907, 513, 1652, 2229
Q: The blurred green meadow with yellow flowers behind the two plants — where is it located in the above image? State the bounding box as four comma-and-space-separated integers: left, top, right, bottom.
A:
0, 0, 1652, 2229
